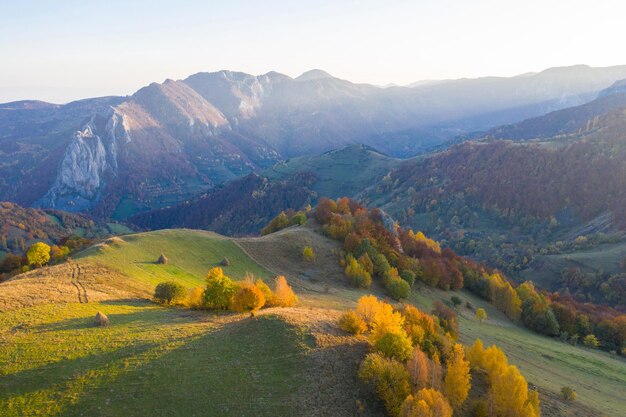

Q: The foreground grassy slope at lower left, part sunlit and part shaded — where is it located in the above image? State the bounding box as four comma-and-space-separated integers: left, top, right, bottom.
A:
0, 301, 312, 417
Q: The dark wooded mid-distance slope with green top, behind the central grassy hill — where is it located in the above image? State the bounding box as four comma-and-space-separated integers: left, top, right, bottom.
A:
128, 145, 401, 236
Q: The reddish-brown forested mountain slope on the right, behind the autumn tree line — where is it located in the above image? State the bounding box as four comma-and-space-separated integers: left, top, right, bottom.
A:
361, 88, 626, 292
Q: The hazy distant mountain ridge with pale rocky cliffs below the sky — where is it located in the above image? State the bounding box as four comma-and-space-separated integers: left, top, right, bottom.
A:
0, 66, 626, 219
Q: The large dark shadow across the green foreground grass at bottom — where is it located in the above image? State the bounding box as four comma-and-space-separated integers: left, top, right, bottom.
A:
58, 316, 308, 417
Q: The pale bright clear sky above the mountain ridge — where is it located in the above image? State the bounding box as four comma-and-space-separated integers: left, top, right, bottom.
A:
0, 0, 626, 103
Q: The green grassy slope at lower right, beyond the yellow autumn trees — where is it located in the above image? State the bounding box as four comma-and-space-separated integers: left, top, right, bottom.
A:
404, 288, 626, 416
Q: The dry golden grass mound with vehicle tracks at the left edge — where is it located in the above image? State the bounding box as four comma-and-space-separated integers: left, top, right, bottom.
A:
0, 262, 151, 312
